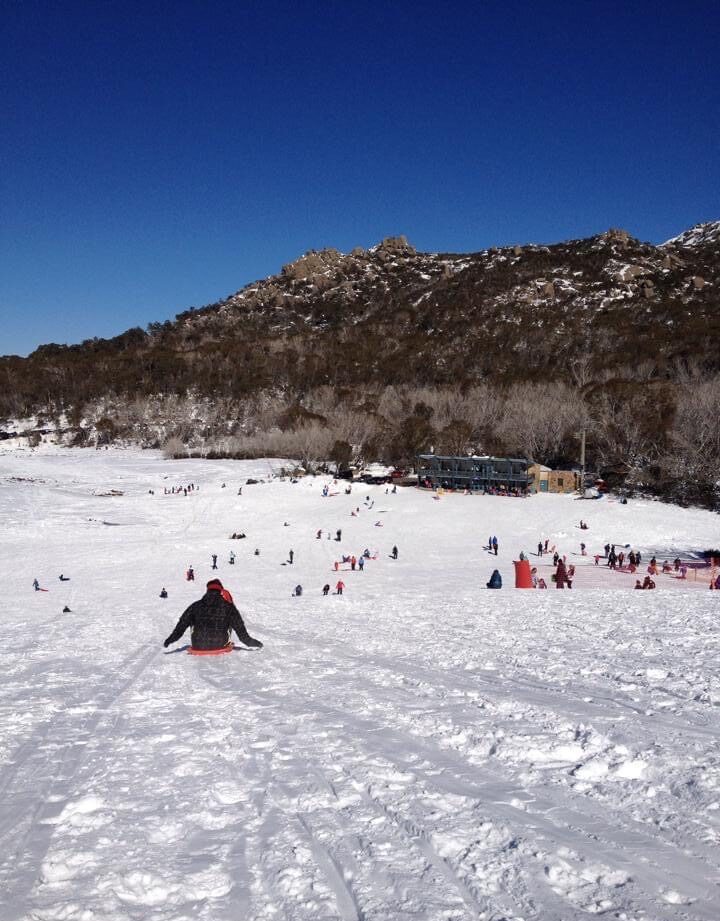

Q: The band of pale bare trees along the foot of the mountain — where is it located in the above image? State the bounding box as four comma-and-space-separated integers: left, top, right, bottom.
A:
5, 361, 720, 507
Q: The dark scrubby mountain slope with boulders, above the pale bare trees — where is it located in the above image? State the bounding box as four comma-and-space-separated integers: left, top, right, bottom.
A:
0, 230, 720, 419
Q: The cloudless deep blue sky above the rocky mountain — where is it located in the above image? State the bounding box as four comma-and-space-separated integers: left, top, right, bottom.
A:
0, 0, 720, 354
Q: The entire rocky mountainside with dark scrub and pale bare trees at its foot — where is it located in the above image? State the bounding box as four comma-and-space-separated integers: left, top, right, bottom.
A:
0, 224, 720, 503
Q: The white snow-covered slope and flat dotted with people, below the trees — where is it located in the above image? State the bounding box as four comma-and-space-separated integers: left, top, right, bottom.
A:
0, 450, 720, 921
